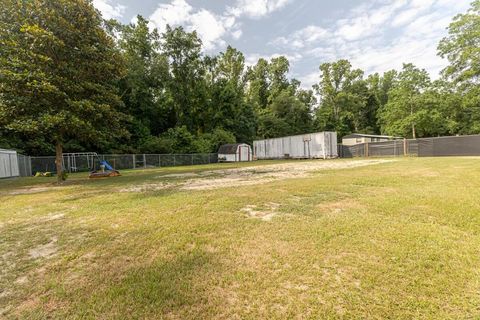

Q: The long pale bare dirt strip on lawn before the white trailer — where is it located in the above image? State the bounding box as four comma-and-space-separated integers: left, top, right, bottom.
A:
120, 159, 394, 192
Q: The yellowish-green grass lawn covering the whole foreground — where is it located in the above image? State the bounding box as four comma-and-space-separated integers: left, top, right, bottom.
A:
0, 158, 480, 319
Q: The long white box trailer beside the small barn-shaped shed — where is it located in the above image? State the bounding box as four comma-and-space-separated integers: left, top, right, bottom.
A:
253, 132, 338, 160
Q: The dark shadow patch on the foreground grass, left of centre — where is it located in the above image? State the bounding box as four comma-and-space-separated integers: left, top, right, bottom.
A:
76, 250, 220, 319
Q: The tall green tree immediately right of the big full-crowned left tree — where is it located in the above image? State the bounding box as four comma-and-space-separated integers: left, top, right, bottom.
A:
119, 16, 173, 144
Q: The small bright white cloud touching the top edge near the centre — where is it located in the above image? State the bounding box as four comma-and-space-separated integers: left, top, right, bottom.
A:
227, 0, 292, 19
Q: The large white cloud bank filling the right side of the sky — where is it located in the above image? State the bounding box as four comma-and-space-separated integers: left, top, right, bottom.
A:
271, 0, 468, 87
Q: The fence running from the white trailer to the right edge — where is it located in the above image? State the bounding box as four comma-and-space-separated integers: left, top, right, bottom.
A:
338, 135, 480, 158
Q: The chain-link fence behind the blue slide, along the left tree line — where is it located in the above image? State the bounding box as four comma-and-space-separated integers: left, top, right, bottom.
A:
30, 153, 218, 174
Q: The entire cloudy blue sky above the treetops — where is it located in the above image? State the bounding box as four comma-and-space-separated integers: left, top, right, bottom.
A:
93, 0, 470, 88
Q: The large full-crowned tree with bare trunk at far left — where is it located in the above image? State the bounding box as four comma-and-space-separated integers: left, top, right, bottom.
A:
0, 0, 124, 181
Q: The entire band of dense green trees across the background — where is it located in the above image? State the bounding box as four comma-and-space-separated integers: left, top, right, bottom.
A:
0, 0, 480, 155
